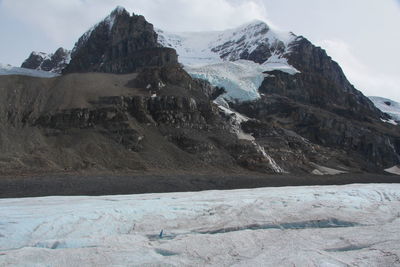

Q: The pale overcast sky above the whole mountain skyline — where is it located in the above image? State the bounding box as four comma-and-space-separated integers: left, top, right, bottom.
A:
0, 0, 400, 101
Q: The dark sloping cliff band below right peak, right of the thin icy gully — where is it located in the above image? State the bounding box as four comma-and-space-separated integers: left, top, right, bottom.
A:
231, 95, 400, 172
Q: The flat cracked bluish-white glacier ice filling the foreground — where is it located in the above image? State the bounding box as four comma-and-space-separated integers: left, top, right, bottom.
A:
0, 184, 400, 266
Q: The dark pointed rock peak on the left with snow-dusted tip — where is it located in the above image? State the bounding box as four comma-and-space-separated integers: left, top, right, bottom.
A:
64, 8, 177, 73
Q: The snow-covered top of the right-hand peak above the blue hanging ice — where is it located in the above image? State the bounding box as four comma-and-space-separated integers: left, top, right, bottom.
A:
157, 20, 296, 66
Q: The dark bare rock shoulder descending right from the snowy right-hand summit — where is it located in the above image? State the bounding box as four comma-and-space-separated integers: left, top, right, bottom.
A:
260, 37, 385, 120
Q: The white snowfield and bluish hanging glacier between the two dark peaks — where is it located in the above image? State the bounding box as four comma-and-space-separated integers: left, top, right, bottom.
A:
157, 21, 298, 101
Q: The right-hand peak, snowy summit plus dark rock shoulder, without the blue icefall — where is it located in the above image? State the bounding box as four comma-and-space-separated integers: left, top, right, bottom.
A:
158, 21, 385, 122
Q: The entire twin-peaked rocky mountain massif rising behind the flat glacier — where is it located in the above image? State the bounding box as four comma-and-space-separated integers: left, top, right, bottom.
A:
5, 7, 400, 175
